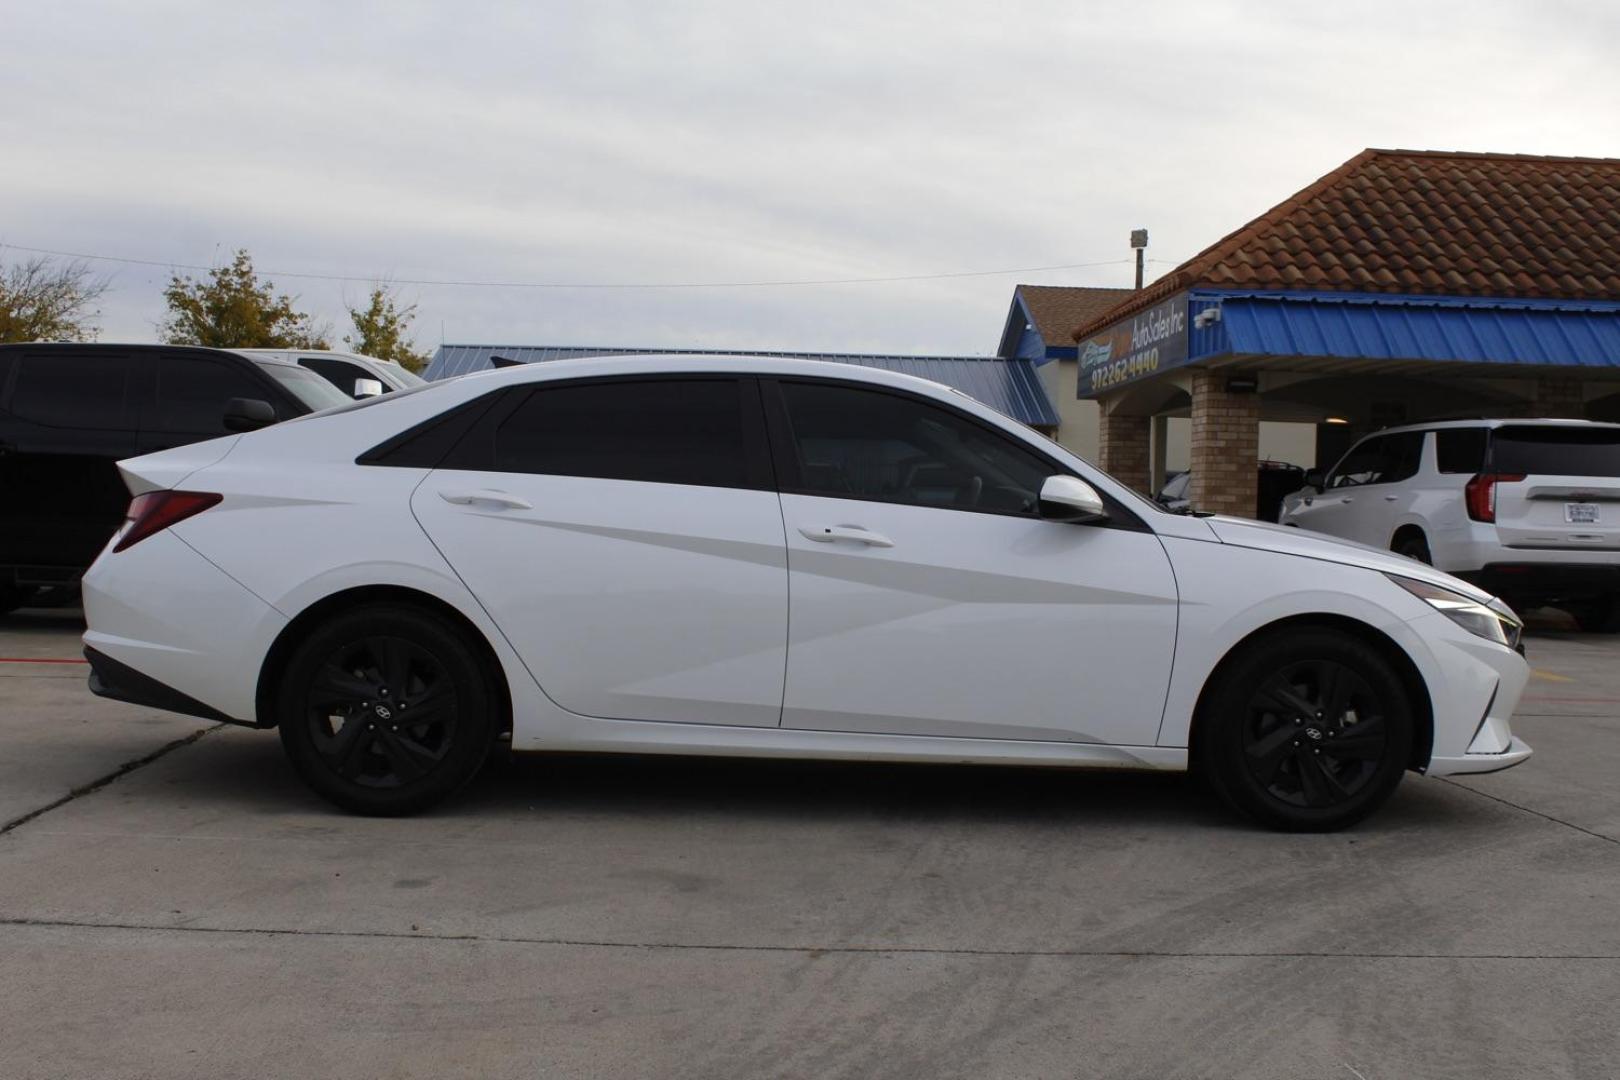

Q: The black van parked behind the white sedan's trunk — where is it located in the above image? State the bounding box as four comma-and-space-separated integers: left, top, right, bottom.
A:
0, 343, 350, 612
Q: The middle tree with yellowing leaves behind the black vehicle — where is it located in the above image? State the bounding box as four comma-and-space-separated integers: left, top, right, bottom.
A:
159, 248, 330, 348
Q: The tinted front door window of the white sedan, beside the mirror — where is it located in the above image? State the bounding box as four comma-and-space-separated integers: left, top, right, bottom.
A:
781, 382, 1056, 515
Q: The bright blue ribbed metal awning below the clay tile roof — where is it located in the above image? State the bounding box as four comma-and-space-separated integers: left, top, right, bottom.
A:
1218, 293, 1620, 368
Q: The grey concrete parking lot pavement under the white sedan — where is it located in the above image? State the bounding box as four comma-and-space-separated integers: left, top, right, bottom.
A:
0, 612, 1620, 1080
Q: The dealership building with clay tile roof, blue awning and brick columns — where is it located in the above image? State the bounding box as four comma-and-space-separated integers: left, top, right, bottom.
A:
1056, 151, 1620, 515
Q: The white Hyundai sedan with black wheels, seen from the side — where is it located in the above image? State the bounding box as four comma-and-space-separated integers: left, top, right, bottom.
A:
84, 356, 1529, 829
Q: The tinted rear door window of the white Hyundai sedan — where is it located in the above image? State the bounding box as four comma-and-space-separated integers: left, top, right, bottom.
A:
494, 379, 753, 487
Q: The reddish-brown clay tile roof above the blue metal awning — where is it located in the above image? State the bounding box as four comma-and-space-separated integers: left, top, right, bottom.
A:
1072, 151, 1620, 340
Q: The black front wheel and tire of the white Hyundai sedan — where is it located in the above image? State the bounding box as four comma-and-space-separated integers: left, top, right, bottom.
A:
1194, 628, 1413, 832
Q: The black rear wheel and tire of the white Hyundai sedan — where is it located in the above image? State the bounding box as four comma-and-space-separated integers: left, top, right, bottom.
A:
275, 604, 501, 816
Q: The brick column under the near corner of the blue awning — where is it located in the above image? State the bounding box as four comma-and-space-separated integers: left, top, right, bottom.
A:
1187, 371, 1260, 518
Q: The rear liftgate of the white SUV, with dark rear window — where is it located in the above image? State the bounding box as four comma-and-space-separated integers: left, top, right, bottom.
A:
1486, 424, 1620, 551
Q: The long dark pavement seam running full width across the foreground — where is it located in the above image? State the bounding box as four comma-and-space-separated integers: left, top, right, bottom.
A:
0, 916, 1620, 962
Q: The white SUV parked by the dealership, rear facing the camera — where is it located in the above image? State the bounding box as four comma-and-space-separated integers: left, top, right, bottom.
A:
1280, 419, 1620, 630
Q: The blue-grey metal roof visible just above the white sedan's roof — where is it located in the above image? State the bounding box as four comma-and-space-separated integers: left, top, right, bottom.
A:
423, 345, 1058, 427
